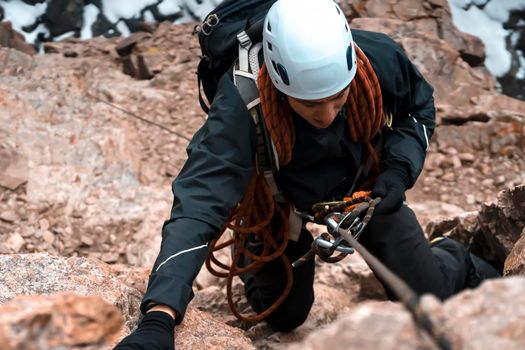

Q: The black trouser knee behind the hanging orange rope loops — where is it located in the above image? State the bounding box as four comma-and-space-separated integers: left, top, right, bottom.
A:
243, 230, 315, 332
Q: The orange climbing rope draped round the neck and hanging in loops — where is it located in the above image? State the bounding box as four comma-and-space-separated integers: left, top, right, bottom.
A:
206, 43, 385, 323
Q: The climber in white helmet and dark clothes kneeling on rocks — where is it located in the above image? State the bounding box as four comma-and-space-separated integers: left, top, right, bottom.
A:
112, 0, 498, 350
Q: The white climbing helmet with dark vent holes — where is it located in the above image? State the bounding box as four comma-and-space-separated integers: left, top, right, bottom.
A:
263, 0, 357, 100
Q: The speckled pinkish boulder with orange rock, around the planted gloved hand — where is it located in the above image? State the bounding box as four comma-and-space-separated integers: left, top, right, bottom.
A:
0, 254, 254, 350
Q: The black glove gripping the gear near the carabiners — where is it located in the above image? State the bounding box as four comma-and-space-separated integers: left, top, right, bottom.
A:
372, 165, 409, 215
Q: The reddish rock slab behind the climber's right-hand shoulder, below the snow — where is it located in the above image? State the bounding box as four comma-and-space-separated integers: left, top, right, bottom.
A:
352, 18, 525, 123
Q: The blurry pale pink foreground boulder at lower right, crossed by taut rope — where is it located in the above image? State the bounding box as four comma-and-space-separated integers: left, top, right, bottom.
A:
289, 277, 525, 350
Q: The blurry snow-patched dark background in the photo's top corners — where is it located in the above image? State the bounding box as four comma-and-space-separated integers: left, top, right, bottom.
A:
0, 0, 525, 100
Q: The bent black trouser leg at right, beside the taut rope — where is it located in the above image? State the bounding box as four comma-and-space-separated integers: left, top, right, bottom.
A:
360, 206, 471, 299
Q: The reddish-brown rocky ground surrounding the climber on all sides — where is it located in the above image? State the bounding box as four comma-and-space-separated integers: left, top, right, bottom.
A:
0, 0, 525, 349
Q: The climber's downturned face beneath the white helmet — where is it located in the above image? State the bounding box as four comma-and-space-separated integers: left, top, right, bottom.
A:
287, 86, 350, 129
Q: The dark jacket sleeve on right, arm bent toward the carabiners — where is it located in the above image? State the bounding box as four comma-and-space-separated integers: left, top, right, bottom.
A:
374, 36, 436, 188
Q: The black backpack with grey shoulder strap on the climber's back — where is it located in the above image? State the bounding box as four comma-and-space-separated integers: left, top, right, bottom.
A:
193, 0, 279, 174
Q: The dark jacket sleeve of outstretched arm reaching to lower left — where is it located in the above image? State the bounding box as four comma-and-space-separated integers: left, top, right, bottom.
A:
141, 75, 255, 324
